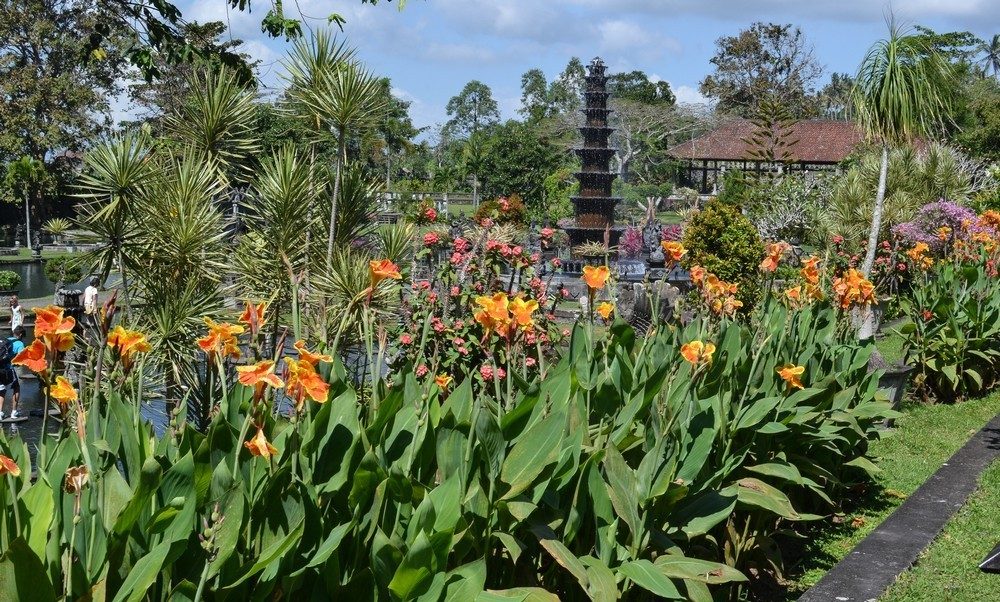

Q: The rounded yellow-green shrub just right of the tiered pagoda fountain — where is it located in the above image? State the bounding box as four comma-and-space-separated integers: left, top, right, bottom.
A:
683, 199, 764, 311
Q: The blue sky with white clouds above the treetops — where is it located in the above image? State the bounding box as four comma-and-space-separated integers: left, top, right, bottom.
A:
178, 0, 1000, 131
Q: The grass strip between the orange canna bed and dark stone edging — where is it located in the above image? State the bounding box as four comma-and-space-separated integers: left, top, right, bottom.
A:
786, 392, 1000, 600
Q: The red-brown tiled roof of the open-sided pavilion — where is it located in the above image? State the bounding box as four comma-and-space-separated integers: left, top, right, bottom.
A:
669, 119, 864, 163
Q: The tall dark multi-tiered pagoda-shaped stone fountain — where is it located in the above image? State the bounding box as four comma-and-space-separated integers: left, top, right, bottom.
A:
566, 57, 625, 247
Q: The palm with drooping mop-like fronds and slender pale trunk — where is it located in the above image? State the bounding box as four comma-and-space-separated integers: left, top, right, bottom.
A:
851, 21, 952, 338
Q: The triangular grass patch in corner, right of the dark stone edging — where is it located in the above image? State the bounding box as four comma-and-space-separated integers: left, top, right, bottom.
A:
880, 462, 1000, 602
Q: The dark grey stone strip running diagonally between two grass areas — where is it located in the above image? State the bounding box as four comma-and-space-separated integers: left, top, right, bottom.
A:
799, 414, 1000, 602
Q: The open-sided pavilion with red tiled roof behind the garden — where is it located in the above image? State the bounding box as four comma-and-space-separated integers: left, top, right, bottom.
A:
669, 119, 864, 194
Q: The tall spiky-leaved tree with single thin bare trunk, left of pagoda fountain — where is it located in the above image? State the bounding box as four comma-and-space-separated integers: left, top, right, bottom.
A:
288, 29, 387, 268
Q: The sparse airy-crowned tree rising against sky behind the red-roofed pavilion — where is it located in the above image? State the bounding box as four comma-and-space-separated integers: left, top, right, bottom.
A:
699, 22, 823, 117
